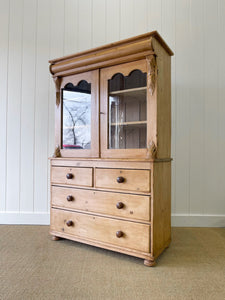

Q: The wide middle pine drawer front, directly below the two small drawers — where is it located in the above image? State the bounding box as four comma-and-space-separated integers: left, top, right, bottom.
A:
52, 186, 150, 221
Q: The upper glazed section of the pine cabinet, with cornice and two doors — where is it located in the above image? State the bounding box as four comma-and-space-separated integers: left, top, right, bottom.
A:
51, 32, 173, 160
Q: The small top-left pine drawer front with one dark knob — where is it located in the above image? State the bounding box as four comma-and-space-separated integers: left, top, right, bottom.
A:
51, 167, 93, 186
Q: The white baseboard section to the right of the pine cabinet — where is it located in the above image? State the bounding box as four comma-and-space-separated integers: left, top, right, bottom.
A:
171, 214, 225, 227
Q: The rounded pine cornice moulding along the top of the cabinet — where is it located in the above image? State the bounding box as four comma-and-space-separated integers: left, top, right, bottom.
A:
49, 31, 173, 77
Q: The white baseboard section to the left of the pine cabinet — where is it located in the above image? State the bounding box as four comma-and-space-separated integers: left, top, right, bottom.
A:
0, 211, 50, 225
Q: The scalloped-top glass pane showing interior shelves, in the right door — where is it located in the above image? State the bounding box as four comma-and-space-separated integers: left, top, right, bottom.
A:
108, 70, 147, 149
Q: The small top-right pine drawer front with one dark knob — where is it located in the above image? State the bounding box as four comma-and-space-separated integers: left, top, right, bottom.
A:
96, 168, 151, 192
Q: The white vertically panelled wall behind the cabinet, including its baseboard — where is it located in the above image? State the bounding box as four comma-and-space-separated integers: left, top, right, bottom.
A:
0, 0, 225, 226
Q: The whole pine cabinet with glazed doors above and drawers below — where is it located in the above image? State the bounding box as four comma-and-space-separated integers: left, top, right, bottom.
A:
50, 31, 173, 266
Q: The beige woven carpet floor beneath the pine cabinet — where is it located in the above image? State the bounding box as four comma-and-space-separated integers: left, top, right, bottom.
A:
0, 225, 225, 300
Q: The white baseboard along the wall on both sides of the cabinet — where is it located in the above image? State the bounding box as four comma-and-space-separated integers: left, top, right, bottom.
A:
0, 211, 225, 227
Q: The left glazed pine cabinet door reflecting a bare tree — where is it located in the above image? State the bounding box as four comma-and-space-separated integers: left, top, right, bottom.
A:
57, 71, 99, 157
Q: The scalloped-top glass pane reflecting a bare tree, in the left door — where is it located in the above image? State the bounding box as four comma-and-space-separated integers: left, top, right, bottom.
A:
62, 80, 91, 149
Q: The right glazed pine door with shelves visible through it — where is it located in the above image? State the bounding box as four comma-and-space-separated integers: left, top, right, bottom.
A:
101, 60, 147, 158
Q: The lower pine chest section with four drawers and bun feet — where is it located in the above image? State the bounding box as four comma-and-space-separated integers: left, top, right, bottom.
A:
50, 159, 170, 266
